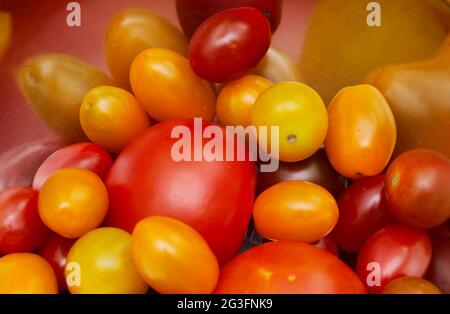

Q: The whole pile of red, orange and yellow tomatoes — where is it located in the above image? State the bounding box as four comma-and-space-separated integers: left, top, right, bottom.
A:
0, 1, 450, 293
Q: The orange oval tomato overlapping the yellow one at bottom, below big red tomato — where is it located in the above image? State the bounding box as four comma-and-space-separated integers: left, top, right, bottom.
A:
133, 216, 219, 294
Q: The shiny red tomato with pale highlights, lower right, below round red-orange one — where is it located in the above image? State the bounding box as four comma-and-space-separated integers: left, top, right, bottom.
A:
356, 224, 431, 293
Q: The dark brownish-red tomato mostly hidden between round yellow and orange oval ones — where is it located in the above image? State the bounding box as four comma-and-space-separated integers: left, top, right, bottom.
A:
258, 148, 346, 197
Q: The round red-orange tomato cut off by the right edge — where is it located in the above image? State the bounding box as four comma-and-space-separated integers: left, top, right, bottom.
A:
386, 149, 450, 229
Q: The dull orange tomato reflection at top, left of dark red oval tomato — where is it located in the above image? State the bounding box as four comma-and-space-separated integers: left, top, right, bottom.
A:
104, 9, 188, 90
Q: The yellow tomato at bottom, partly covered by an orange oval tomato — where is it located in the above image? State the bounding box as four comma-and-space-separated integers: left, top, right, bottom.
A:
65, 228, 148, 294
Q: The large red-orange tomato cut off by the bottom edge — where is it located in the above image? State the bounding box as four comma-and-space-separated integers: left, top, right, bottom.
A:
215, 241, 366, 294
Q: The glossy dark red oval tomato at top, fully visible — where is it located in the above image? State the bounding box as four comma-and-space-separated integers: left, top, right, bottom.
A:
188, 8, 271, 83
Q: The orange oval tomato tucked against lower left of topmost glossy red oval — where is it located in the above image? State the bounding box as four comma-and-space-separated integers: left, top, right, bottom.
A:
130, 48, 216, 121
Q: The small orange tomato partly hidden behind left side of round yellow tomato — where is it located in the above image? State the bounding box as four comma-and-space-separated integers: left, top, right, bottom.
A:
216, 75, 272, 127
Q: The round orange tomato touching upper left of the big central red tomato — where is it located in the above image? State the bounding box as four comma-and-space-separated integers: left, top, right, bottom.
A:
80, 86, 150, 153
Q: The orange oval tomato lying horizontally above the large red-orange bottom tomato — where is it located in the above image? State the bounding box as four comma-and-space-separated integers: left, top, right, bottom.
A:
253, 181, 339, 243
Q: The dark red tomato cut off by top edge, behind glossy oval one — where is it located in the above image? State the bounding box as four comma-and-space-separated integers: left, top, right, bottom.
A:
176, 0, 282, 38
